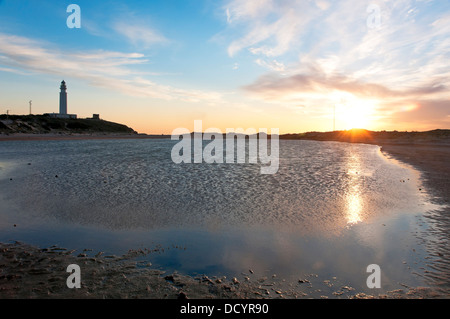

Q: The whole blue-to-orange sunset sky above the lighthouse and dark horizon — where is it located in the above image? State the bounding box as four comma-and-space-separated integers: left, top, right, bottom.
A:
0, 0, 450, 134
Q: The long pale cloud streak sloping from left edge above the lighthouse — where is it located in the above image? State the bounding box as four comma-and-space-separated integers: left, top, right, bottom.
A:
0, 33, 221, 102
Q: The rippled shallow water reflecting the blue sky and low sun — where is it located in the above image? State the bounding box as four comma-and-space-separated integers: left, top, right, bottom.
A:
0, 139, 445, 296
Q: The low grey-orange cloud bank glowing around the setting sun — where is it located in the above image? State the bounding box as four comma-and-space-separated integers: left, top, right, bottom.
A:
243, 58, 450, 130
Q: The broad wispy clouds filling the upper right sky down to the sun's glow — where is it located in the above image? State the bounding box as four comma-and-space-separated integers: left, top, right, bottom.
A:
224, 0, 450, 130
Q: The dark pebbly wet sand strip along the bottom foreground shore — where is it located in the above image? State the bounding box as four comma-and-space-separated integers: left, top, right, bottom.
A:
0, 242, 442, 299
